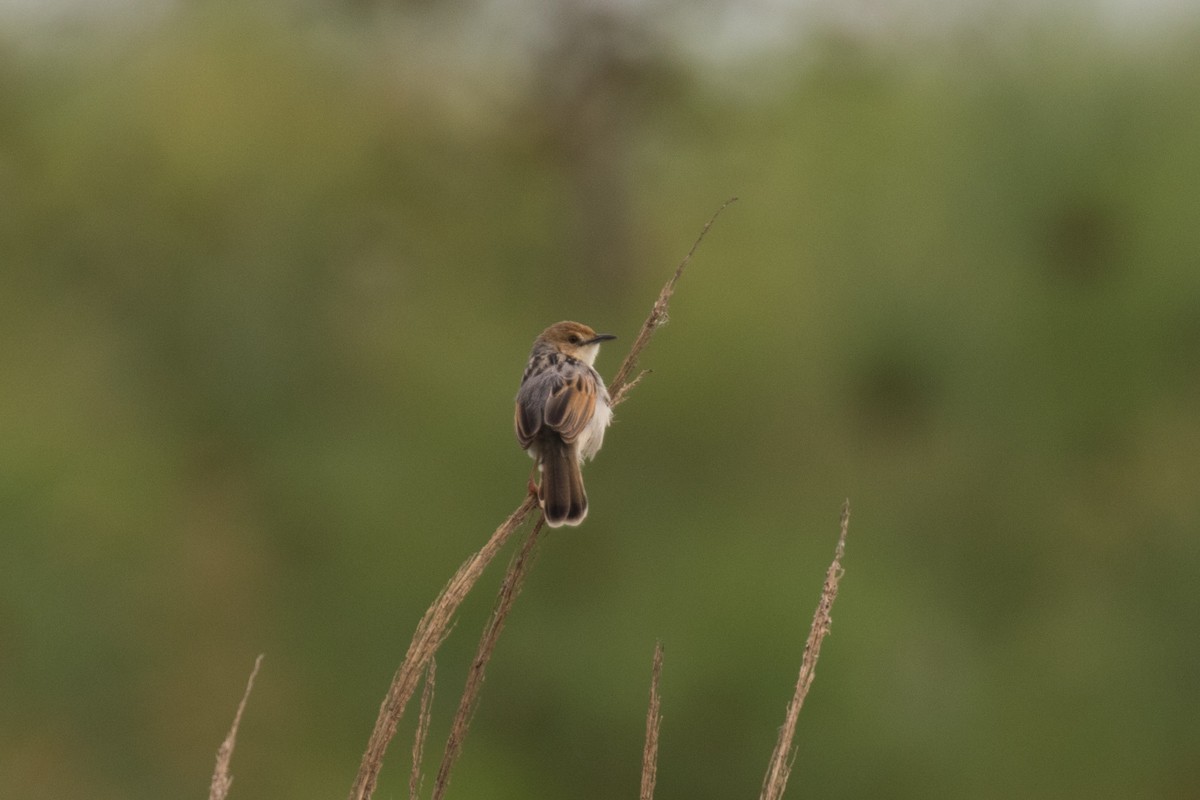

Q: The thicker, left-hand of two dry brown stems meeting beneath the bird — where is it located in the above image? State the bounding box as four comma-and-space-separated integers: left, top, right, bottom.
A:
350, 495, 538, 800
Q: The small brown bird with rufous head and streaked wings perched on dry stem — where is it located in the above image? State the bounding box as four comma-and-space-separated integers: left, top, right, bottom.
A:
516, 323, 617, 528
